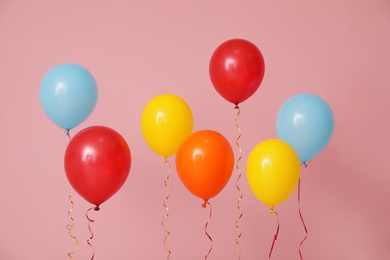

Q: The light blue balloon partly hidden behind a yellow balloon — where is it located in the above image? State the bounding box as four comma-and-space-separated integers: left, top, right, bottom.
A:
276, 93, 334, 162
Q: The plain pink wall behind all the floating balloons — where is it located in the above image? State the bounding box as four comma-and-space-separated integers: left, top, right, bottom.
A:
0, 0, 390, 260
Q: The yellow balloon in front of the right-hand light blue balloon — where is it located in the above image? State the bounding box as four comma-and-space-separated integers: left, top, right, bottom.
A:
246, 139, 300, 209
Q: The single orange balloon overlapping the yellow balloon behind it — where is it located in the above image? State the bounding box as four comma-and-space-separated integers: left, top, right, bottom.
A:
176, 130, 234, 207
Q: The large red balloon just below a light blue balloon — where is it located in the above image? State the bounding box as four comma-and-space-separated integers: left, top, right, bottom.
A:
64, 126, 131, 207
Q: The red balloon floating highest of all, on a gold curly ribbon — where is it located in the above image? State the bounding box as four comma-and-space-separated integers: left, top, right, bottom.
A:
209, 39, 265, 107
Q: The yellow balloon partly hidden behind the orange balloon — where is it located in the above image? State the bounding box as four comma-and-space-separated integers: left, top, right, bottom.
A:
141, 94, 194, 160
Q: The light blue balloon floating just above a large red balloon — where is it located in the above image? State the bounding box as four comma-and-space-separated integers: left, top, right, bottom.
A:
39, 63, 98, 130
